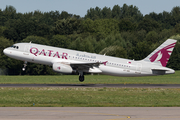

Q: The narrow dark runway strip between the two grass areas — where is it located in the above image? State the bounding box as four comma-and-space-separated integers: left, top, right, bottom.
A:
0, 84, 180, 88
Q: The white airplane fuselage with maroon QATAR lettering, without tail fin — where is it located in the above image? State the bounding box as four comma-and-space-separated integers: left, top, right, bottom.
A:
3, 43, 175, 76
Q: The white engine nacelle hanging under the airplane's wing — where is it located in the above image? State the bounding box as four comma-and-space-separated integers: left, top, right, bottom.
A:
52, 63, 73, 74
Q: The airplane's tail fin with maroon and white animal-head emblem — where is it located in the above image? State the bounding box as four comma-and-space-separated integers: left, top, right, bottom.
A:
143, 39, 177, 67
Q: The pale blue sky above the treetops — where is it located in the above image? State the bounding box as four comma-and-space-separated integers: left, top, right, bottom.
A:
0, 0, 180, 17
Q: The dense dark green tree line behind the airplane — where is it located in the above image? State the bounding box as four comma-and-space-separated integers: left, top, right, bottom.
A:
0, 4, 180, 75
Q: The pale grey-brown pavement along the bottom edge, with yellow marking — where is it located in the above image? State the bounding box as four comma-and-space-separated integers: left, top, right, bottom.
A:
0, 107, 180, 120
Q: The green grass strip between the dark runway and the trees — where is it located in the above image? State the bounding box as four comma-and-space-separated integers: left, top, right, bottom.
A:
0, 71, 180, 84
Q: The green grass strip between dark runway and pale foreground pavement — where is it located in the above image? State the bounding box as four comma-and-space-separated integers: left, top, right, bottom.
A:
0, 87, 180, 107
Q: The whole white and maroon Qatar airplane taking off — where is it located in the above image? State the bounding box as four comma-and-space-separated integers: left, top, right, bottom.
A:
3, 39, 177, 82
